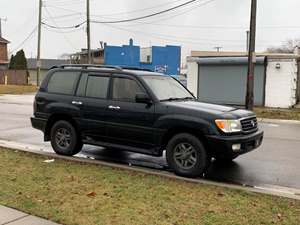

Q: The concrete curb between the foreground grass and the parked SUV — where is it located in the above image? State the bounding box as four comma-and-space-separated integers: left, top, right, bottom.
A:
0, 140, 300, 200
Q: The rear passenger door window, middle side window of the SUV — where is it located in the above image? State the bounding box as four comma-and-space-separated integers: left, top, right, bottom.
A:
86, 76, 109, 98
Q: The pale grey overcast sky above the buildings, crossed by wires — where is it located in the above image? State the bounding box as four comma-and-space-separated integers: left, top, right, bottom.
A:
0, 0, 300, 61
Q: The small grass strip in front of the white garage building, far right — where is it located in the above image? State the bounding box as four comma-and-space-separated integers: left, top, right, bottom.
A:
254, 108, 300, 120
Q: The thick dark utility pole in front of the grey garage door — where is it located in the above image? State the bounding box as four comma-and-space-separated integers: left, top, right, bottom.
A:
246, 0, 257, 110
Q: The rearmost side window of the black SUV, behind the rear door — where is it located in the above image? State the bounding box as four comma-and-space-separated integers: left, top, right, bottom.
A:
47, 71, 79, 95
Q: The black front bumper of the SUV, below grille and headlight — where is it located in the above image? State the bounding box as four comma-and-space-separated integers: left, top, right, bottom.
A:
207, 131, 264, 158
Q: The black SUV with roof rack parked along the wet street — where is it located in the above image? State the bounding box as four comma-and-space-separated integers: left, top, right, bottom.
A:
31, 65, 263, 177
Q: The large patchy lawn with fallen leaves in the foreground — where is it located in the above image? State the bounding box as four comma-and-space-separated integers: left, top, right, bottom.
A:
0, 149, 300, 225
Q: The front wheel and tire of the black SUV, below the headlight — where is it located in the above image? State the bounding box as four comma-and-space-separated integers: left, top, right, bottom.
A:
166, 133, 211, 178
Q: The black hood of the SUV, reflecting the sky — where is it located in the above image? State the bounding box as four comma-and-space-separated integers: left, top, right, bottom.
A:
165, 101, 255, 119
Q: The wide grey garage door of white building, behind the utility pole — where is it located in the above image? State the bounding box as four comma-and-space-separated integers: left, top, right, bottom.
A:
198, 57, 265, 106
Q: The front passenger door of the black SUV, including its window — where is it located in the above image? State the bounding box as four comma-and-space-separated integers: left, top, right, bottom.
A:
107, 77, 154, 148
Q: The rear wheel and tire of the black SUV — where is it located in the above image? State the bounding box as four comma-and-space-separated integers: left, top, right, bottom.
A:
51, 120, 83, 156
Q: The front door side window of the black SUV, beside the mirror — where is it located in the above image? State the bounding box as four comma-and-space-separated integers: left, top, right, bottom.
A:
112, 77, 145, 102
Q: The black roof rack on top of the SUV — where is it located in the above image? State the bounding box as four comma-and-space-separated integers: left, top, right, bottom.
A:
51, 64, 153, 72
